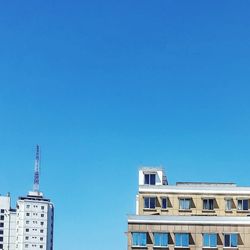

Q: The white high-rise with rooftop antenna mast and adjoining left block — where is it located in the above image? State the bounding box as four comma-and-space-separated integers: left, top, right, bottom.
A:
0, 147, 54, 250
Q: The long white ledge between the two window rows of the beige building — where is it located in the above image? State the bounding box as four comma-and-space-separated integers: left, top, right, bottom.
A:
128, 215, 250, 225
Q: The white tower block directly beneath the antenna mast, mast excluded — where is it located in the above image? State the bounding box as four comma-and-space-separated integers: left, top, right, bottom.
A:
16, 192, 54, 250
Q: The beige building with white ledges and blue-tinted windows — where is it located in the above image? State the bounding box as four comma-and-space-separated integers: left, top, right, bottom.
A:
128, 168, 250, 250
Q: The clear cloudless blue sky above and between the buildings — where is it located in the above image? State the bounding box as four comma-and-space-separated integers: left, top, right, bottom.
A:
0, 0, 250, 250
